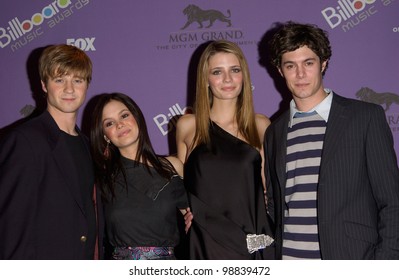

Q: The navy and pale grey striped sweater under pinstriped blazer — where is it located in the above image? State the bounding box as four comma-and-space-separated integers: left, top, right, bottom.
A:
283, 112, 326, 259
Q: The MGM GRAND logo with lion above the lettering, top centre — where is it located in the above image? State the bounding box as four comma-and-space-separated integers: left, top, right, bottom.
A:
169, 4, 244, 47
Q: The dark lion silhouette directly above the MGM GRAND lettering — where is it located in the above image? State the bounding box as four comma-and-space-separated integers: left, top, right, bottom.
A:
181, 5, 231, 30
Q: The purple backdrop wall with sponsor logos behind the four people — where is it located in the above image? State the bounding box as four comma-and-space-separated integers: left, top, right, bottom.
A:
0, 0, 399, 160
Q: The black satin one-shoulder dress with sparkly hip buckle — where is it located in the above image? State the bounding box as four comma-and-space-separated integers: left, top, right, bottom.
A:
184, 122, 274, 260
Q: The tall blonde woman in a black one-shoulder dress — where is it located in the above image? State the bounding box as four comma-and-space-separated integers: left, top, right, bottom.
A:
176, 41, 274, 259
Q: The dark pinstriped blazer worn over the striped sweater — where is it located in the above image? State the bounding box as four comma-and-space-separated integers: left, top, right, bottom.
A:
265, 93, 399, 259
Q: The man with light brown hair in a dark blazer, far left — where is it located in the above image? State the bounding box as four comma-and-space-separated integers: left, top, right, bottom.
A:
0, 45, 101, 260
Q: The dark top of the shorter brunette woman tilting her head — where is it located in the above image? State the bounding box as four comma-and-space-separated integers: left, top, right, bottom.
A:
104, 157, 188, 247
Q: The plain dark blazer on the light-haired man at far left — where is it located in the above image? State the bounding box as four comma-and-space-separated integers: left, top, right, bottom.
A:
0, 111, 102, 260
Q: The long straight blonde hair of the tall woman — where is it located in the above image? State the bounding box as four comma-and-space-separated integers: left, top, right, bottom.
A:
191, 40, 261, 150
